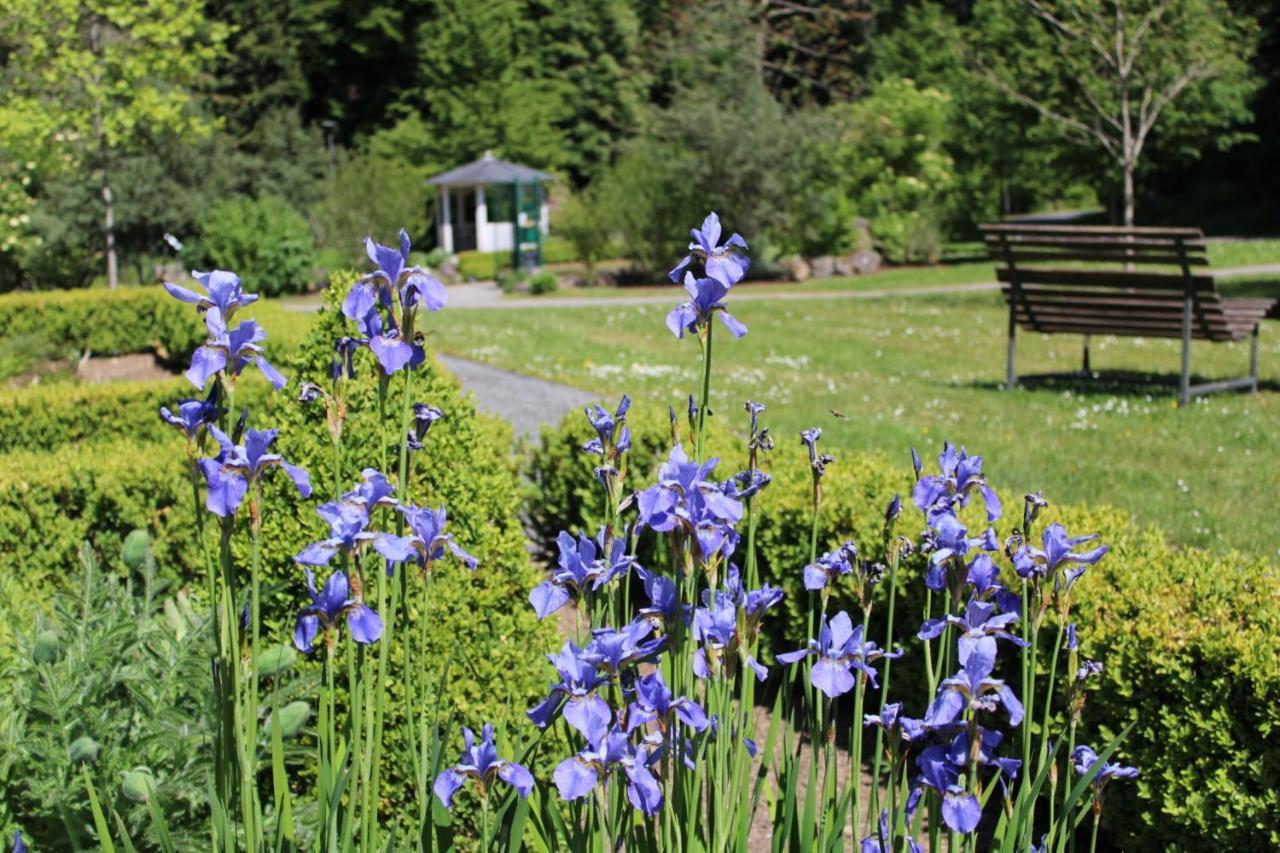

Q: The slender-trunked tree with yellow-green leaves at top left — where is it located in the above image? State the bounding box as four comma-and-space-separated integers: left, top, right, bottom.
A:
0, 0, 227, 287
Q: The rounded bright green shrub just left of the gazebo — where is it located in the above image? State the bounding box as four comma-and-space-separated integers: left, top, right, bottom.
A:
193, 196, 316, 296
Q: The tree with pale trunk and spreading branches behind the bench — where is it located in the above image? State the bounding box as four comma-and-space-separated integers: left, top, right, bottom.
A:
974, 0, 1257, 225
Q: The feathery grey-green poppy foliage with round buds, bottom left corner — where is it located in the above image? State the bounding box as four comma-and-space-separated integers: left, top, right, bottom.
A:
0, 547, 218, 850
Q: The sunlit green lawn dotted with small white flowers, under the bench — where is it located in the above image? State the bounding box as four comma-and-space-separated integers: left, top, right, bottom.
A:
433, 286, 1280, 558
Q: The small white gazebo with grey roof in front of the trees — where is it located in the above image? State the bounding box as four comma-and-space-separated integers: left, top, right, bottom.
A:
428, 152, 554, 255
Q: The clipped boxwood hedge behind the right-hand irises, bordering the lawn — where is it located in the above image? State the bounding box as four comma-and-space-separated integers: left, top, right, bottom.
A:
526, 403, 1280, 849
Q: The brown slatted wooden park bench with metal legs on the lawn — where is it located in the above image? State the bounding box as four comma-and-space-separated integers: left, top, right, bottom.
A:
980, 224, 1280, 406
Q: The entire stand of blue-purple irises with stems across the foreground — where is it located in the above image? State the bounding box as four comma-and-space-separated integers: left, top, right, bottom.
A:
7, 214, 1152, 850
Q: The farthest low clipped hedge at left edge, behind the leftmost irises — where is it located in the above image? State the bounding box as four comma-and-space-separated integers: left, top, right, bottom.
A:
0, 287, 205, 362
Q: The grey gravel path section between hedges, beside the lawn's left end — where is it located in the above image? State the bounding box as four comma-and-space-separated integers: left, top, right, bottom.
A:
435, 353, 595, 438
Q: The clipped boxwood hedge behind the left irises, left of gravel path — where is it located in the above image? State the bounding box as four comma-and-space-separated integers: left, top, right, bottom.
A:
0, 277, 556, 808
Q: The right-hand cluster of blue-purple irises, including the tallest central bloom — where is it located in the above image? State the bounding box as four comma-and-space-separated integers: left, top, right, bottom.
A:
424, 214, 1137, 852
